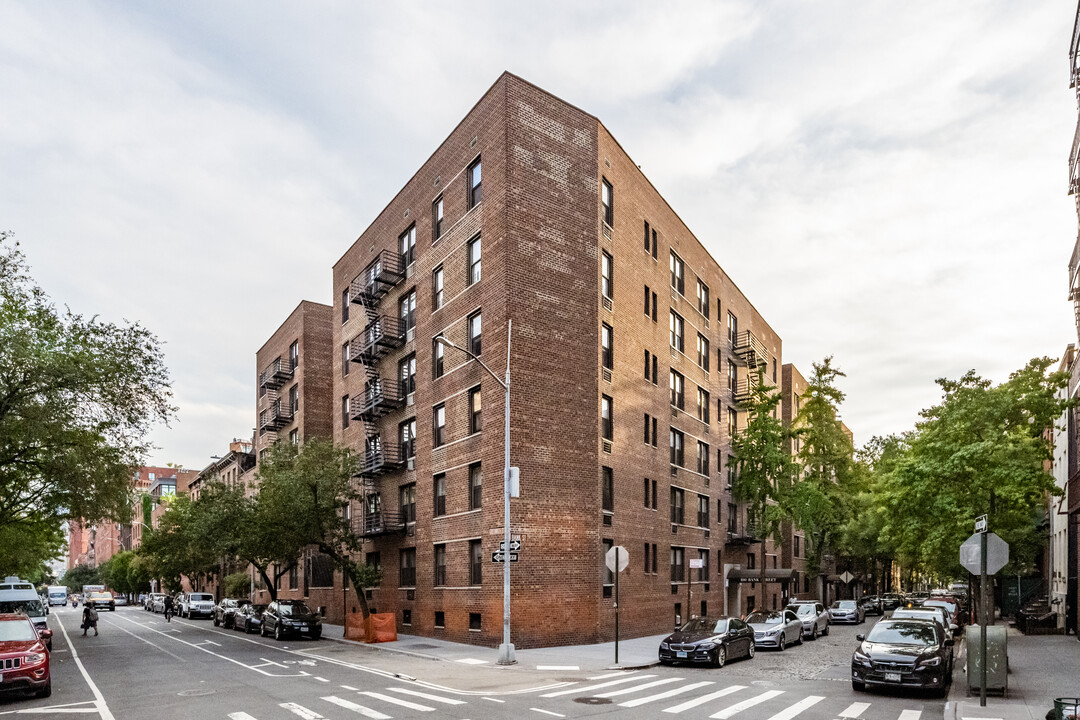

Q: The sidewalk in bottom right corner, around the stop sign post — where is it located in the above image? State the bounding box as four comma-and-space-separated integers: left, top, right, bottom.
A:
945, 627, 1080, 720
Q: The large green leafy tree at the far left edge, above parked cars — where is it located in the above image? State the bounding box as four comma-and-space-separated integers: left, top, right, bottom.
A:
0, 233, 175, 556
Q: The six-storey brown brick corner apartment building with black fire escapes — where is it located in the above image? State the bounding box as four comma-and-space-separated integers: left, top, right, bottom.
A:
315, 73, 820, 648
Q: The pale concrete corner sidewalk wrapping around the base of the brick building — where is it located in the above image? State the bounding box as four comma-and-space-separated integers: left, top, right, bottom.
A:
323, 623, 660, 671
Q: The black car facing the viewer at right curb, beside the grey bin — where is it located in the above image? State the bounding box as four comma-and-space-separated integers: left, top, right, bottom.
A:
851, 619, 953, 697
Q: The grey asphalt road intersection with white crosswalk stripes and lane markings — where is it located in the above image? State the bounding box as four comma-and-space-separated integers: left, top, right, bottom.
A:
0, 608, 946, 720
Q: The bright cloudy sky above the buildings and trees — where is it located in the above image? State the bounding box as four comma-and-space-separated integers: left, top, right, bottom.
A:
0, 0, 1077, 467
